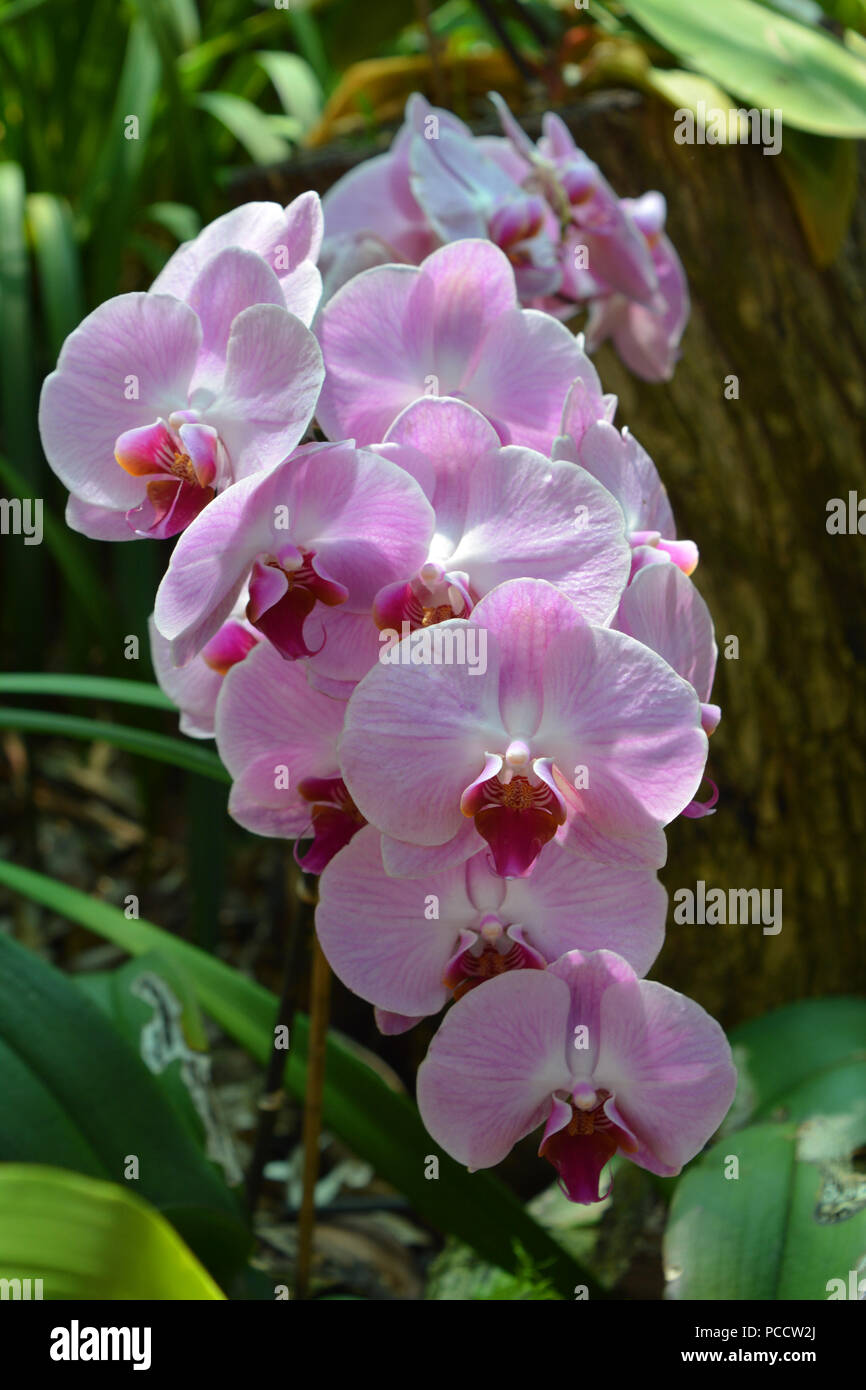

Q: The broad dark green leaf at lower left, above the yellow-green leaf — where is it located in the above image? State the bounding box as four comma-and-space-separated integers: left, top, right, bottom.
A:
0, 913, 249, 1277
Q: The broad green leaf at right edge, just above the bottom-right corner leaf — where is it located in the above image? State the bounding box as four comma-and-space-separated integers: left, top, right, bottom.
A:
726, 995, 866, 1129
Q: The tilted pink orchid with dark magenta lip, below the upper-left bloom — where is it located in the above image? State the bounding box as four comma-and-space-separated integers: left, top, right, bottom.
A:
154, 443, 434, 676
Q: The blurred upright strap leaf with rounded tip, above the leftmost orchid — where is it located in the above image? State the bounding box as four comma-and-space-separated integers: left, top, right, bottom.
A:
26, 193, 85, 357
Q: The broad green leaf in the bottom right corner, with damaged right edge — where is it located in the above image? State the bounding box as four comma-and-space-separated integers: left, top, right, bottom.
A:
663, 1112, 866, 1300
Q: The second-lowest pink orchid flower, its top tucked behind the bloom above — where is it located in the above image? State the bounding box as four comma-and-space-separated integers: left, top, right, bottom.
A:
316, 826, 667, 1031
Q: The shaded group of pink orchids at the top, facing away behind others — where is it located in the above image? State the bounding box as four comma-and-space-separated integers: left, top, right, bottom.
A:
322, 93, 689, 381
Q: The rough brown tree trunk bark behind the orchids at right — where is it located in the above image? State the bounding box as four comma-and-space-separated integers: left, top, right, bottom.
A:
243, 95, 866, 1026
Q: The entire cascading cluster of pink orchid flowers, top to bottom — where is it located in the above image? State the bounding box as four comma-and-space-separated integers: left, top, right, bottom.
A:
40, 97, 734, 1202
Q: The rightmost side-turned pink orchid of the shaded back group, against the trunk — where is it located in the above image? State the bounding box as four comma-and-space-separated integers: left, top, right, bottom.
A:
587, 193, 691, 381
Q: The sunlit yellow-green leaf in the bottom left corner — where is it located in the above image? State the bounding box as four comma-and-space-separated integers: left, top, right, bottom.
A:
0, 1163, 224, 1301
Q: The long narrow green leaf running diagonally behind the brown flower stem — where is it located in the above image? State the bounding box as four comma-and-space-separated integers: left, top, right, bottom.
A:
0, 860, 603, 1298
